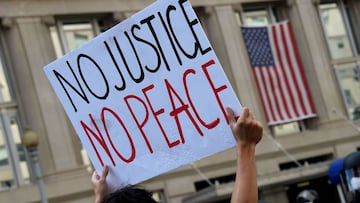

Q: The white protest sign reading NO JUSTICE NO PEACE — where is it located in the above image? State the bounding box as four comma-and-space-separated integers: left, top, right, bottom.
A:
45, 0, 241, 191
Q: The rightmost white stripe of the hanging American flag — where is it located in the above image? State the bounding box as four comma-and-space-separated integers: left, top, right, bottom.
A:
284, 23, 312, 115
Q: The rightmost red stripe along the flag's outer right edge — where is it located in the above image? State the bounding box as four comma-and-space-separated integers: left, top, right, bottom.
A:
286, 21, 315, 114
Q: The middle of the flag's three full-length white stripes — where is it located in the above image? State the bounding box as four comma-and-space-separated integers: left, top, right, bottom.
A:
274, 24, 302, 117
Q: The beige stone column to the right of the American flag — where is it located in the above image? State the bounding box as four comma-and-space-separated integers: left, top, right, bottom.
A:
288, 0, 346, 123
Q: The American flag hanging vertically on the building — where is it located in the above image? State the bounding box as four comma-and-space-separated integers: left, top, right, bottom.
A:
241, 21, 316, 125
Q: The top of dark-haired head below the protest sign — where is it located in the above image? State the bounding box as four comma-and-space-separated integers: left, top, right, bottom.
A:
103, 185, 157, 203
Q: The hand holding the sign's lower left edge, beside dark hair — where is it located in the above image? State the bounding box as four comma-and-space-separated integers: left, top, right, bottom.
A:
91, 166, 109, 203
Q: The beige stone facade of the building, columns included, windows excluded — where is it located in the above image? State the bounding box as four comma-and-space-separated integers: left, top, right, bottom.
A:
0, 0, 360, 203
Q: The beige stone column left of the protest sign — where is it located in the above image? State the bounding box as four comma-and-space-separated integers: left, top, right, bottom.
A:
5, 17, 81, 176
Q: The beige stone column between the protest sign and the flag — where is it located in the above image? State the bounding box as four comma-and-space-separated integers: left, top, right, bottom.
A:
201, 5, 268, 131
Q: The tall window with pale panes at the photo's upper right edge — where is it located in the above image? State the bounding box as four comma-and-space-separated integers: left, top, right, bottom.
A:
319, 0, 360, 120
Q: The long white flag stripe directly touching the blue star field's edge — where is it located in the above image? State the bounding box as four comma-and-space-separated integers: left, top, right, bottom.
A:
268, 26, 296, 119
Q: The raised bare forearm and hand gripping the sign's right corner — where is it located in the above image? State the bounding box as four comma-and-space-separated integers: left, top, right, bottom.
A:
227, 107, 263, 203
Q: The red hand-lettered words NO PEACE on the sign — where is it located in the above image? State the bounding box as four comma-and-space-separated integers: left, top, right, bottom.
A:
80, 60, 229, 166
